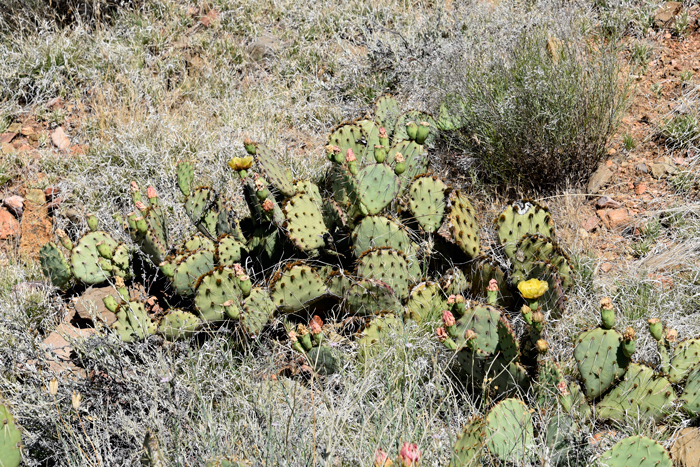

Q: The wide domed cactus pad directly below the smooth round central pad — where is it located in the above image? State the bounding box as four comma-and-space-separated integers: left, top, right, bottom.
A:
352, 216, 413, 257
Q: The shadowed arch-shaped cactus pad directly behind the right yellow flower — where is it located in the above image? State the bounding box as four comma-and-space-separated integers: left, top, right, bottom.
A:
511, 234, 573, 289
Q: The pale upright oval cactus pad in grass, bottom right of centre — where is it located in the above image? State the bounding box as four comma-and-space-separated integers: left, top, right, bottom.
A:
485, 398, 534, 464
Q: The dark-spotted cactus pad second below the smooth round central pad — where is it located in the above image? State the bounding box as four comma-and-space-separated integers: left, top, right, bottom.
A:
357, 247, 413, 299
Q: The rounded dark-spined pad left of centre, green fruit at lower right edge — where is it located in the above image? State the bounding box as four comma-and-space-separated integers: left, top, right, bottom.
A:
194, 267, 243, 321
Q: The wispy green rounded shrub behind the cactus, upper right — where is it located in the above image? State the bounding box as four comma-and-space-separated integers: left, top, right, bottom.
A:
441, 31, 626, 191
